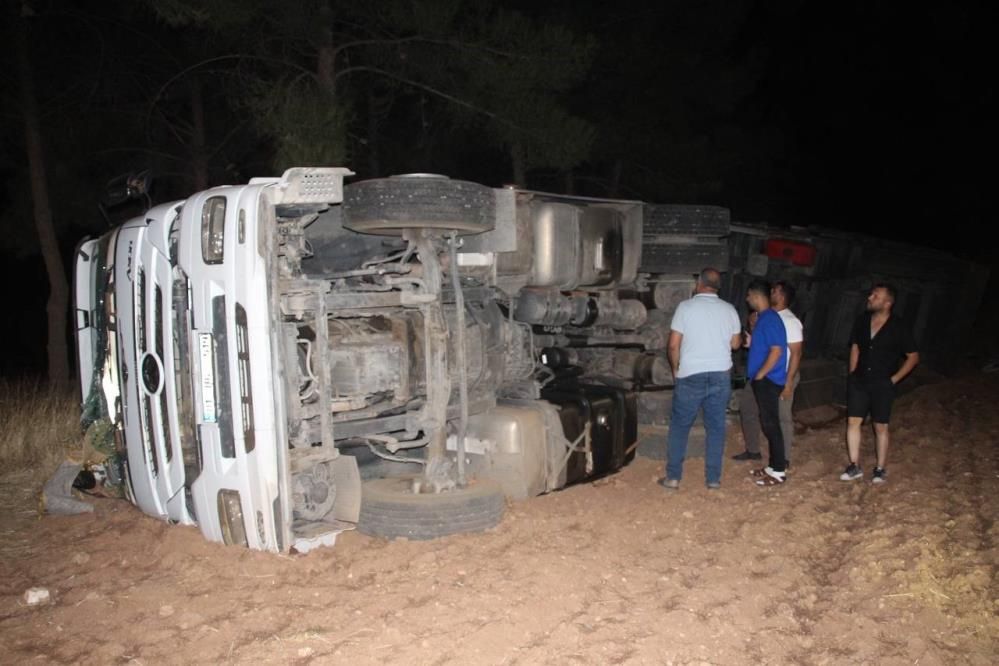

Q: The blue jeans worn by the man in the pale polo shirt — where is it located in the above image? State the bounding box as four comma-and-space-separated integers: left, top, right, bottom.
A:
666, 370, 732, 483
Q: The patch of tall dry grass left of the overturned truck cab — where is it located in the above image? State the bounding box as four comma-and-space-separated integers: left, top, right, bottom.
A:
0, 379, 83, 481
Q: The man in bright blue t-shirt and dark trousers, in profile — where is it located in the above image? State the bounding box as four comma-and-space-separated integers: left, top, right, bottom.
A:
746, 280, 787, 486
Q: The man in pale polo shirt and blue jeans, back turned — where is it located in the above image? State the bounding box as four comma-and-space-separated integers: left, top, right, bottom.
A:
659, 268, 742, 490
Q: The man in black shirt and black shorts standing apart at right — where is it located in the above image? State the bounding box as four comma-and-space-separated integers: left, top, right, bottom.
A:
839, 284, 919, 483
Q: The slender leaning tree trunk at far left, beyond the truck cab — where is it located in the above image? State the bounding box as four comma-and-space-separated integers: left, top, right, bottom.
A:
14, 11, 70, 388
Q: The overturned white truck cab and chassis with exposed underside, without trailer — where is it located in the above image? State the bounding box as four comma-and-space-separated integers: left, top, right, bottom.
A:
75, 168, 728, 551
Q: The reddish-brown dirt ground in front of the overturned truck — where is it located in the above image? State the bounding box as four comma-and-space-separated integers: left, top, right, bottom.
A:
0, 375, 999, 664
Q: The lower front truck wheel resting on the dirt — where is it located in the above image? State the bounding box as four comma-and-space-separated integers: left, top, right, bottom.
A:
357, 476, 506, 541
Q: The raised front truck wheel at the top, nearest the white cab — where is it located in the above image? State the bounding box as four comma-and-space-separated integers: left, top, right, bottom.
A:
343, 174, 496, 235
